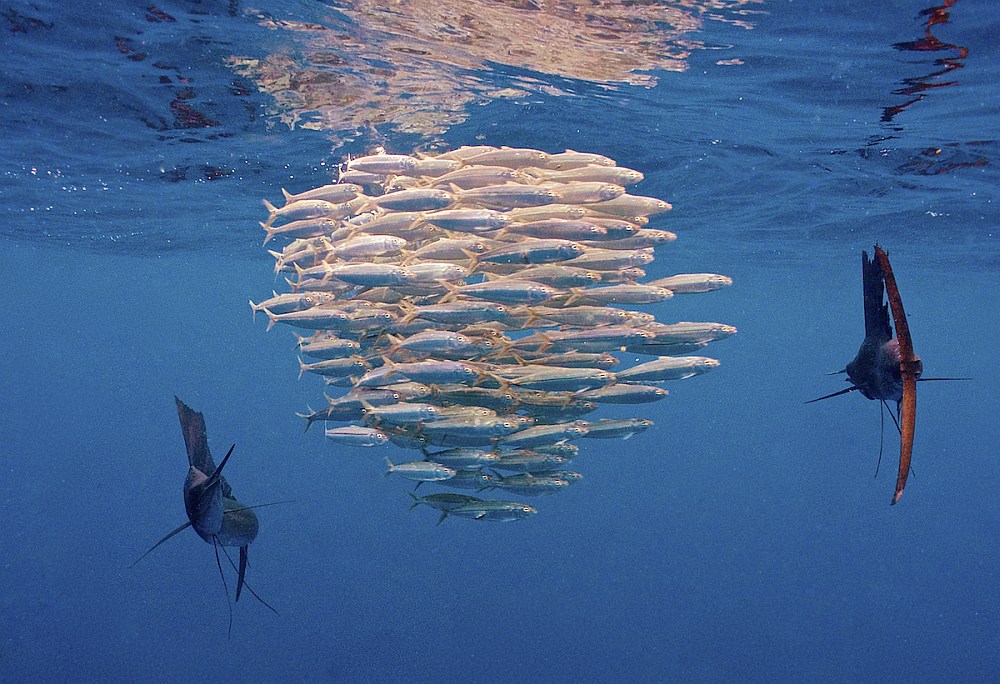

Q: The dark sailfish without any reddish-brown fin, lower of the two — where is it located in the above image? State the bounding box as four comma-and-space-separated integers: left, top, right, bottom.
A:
132, 397, 278, 633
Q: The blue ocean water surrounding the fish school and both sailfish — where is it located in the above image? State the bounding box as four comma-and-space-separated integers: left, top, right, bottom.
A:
0, 0, 1000, 682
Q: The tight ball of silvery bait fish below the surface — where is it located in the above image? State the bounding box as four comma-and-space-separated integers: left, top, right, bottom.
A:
251, 146, 736, 522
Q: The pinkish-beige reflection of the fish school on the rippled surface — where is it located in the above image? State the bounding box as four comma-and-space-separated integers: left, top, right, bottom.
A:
228, 0, 758, 140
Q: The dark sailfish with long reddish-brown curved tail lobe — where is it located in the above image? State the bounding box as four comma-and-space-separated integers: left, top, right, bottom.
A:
806, 245, 968, 505
